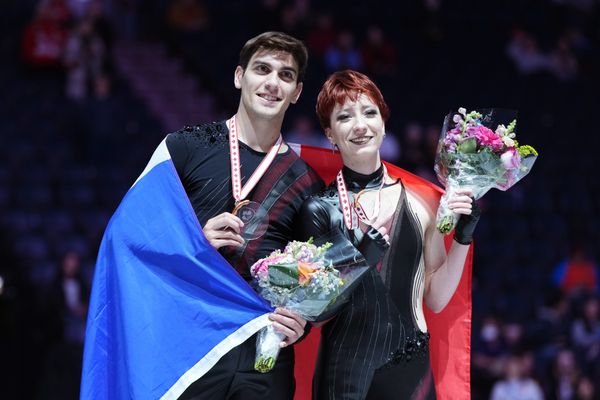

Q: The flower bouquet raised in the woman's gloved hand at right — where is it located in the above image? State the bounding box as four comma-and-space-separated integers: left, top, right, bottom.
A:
435, 108, 538, 234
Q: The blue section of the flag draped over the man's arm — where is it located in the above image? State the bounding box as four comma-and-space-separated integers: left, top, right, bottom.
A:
81, 155, 272, 400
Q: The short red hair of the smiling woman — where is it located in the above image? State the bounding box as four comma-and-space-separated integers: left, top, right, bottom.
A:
316, 69, 390, 129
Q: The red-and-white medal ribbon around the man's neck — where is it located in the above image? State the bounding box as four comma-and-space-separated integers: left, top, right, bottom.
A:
227, 115, 283, 205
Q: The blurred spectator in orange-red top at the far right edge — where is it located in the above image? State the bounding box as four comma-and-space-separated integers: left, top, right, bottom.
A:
553, 243, 600, 293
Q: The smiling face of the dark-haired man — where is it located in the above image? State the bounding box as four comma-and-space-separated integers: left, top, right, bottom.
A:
234, 50, 302, 119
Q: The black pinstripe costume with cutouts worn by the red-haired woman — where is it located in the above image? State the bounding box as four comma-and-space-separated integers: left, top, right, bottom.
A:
301, 167, 435, 400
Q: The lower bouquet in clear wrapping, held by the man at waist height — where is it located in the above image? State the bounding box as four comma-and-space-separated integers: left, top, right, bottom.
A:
250, 233, 369, 372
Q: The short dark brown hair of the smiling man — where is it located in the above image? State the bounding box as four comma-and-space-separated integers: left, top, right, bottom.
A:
238, 32, 308, 82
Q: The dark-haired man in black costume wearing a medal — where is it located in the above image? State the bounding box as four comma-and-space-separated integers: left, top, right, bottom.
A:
166, 32, 322, 399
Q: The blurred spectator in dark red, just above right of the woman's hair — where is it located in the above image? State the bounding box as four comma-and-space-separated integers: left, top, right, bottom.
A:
361, 25, 398, 77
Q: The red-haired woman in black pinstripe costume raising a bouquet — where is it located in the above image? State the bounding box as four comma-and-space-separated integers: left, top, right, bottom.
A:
301, 70, 478, 400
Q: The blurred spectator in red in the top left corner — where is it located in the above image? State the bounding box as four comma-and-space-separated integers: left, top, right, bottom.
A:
21, 1, 68, 67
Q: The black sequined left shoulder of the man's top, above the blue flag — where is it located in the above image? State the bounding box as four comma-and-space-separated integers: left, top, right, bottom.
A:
167, 121, 229, 148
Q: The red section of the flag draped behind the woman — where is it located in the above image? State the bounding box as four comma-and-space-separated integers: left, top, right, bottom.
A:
294, 145, 473, 400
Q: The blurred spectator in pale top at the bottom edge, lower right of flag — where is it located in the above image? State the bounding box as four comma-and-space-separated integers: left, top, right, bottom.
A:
490, 355, 544, 400
